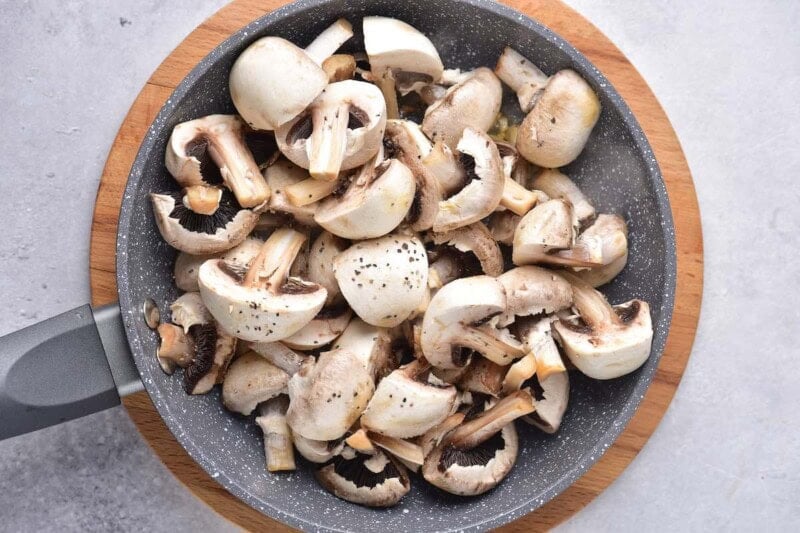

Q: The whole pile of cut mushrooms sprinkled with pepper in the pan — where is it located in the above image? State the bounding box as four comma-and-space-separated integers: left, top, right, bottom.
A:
152, 17, 653, 506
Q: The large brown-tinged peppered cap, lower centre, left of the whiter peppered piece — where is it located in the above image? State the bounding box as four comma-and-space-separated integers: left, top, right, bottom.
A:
286, 349, 375, 441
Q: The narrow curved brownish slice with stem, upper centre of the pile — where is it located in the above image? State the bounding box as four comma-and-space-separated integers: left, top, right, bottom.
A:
383, 120, 442, 231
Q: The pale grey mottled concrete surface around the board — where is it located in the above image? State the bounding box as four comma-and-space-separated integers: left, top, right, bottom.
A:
0, 0, 800, 531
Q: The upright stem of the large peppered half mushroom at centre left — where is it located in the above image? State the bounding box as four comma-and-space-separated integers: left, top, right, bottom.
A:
242, 228, 306, 291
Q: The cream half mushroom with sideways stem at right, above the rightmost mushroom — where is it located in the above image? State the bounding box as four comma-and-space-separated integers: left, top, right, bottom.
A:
512, 200, 603, 267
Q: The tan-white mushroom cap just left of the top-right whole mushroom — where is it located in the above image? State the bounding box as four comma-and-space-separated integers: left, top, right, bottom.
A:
422, 67, 503, 148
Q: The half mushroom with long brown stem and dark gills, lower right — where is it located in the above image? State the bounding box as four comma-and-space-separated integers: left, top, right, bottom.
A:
422, 391, 533, 496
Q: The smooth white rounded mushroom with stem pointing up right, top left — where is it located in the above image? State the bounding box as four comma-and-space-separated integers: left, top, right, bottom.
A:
229, 19, 353, 130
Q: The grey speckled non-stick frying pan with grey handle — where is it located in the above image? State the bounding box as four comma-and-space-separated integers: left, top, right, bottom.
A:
0, 0, 676, 531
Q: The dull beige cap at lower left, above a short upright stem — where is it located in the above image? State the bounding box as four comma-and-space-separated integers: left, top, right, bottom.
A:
222, 351, 289, 416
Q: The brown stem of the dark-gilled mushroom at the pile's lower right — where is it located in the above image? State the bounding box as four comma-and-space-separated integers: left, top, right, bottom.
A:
447, 390, 536, 450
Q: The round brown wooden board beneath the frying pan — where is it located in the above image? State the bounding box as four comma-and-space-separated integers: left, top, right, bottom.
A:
90, 0, 703, 533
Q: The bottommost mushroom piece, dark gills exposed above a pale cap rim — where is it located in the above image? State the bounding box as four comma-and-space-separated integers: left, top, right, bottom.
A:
315, 450, 411, 507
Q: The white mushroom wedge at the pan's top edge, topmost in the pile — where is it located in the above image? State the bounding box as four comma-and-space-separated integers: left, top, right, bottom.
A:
363, 17, 444, 94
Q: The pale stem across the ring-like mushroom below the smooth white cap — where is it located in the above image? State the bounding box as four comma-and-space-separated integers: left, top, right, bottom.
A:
307, 102, 350, 181
